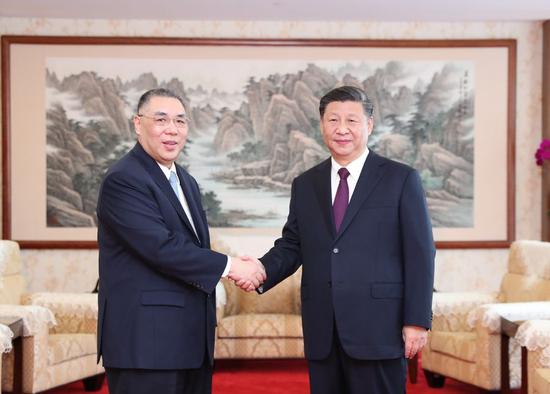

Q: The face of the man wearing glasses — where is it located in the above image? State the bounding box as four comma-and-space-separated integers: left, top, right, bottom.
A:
134, 96, 189, 167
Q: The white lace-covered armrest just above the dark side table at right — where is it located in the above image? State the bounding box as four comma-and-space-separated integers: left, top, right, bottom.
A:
468, 301, 550, 334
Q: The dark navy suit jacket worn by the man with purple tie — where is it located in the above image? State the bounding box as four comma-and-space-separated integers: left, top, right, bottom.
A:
260, 151, 435, 360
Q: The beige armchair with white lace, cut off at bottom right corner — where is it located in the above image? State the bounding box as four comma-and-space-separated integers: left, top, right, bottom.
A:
516, 320, 550, 394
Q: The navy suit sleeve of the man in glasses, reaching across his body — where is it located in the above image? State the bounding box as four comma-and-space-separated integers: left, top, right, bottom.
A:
97, 168, 227, 293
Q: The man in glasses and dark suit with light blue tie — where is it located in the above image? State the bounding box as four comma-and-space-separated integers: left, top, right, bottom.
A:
97, 89, 265, 394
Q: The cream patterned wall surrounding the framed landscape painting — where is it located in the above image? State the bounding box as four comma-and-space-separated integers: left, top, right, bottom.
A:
0, 18, 542, 291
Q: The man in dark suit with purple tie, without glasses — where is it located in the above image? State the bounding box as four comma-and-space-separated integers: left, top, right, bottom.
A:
242, 86, 435, 394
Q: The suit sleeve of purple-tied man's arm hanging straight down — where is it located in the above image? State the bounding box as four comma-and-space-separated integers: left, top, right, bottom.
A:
399, 170, 435, 329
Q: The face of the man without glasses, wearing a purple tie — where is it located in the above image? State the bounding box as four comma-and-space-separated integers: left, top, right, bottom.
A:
321, 101, 373, 166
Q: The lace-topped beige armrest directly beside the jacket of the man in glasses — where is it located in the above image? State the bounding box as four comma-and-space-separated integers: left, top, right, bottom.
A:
22, 293, 98, 334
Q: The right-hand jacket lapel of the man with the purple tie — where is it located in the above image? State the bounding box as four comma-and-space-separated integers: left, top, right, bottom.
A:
329, 151, 384, 239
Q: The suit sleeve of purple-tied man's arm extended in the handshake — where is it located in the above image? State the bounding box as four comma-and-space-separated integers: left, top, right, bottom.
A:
260, 180, 302, 292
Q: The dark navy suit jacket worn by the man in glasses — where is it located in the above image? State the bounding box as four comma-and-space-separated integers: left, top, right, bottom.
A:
97, 143, 227, 369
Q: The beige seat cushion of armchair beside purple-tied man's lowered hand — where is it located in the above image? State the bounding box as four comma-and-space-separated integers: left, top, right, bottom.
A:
430, 331, 477, 362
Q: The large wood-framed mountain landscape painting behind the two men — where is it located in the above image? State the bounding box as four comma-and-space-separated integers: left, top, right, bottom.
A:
2, 36, 516, 248
